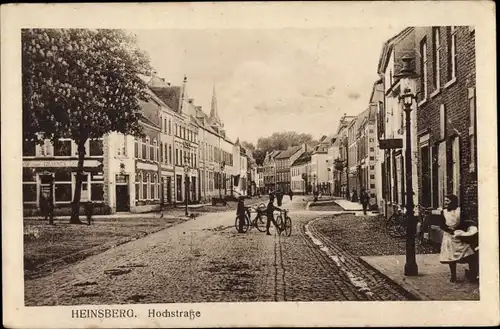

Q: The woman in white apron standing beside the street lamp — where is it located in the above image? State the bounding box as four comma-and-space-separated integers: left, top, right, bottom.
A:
439, 194, 475, 282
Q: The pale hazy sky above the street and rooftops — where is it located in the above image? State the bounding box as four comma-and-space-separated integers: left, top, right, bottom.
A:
132, 27, 401, 143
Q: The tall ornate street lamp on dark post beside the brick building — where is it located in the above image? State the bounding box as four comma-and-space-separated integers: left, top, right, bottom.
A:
394, 55, 418, 276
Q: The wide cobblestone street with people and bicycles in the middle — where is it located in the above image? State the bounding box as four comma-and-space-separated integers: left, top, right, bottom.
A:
25, 196, 418, 306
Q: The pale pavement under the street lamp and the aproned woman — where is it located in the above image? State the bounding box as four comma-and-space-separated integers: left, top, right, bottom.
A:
360, 254, 479, 301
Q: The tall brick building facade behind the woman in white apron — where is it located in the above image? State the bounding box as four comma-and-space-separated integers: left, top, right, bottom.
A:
415, 26, 477, 219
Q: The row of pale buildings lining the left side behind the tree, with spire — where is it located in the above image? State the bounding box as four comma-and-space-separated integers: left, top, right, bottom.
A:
23, 76, 257, 212
